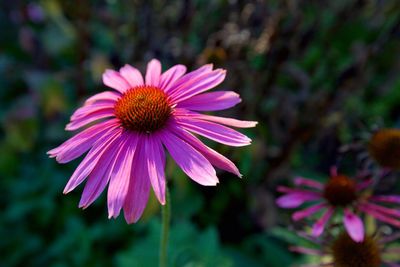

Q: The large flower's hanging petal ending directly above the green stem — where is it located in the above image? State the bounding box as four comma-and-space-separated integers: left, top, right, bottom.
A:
143, 134, 165, 205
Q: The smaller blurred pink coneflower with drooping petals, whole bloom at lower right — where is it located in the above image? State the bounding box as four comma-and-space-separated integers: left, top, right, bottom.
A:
277, 168, 400, 242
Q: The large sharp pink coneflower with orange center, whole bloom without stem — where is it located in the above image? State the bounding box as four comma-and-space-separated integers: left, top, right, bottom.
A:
48, 59, 256, 223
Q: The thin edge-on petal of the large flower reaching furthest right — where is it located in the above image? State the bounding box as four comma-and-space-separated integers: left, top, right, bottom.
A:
174, 108, 257, 128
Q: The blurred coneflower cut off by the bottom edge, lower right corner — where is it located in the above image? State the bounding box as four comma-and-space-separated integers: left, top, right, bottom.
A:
290, 232, 400, 267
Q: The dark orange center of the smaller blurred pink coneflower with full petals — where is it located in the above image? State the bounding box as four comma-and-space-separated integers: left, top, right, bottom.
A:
324, 175, 357, 206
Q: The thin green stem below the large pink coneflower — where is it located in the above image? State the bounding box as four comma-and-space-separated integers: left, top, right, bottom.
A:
159, 187, 171, 267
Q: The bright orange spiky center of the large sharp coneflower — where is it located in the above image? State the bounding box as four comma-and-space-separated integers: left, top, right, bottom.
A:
114, 85, 171, 133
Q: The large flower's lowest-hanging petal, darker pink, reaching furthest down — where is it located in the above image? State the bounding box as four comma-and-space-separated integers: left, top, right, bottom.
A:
124, 142, 150, 223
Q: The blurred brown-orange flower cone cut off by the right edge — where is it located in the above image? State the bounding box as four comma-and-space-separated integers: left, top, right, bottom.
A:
368, 128, 400, 169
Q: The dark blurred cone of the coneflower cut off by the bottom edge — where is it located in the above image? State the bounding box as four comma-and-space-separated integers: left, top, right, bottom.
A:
331, 233, 381, 267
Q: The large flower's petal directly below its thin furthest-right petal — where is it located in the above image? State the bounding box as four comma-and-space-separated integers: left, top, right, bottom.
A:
177, 118, 251, 147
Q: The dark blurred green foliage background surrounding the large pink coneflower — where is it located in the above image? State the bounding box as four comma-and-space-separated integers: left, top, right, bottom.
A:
0, 0, 400, 267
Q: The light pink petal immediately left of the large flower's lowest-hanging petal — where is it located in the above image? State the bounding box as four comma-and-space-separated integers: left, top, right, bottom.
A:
107, 132, 138, 218
